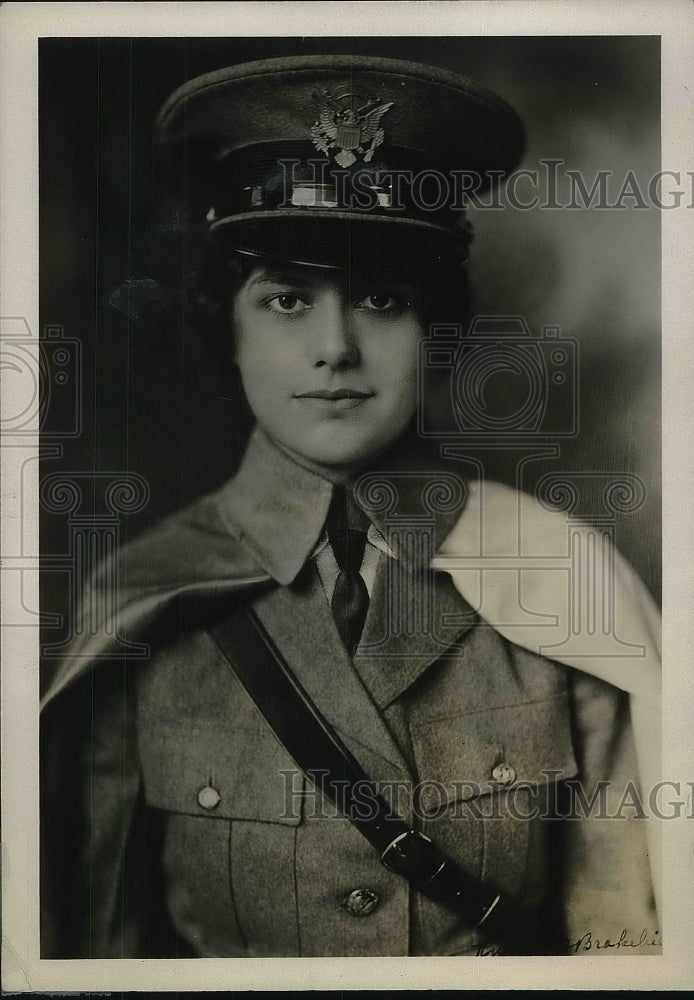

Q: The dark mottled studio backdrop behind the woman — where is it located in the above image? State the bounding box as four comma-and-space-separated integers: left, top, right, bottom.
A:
39, 36, 660, 656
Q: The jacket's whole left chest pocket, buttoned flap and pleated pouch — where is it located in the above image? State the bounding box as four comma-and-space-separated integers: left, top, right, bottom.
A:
139, 717, 304, 957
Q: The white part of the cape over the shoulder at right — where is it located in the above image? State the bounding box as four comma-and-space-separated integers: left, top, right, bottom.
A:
431, 482, 662, 910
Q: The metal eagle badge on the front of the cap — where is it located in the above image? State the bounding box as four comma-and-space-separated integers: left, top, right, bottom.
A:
311, 90, 393, 168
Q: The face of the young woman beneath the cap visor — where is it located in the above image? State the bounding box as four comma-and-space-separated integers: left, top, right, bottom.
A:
233, 264, 424, 466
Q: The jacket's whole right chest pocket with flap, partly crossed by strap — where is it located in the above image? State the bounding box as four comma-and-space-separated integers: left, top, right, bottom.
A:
412, 691, 577, 954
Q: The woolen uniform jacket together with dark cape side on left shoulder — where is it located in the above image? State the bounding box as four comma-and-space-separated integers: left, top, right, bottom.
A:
42, 431, 659, 958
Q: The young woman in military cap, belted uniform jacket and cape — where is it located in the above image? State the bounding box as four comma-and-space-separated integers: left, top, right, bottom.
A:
44, 57, 659, 957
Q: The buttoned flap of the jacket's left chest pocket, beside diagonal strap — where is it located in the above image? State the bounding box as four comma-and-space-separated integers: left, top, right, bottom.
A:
139, 720, 304, 826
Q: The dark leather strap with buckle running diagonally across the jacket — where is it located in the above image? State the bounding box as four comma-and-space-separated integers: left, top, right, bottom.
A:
209, 608, 560, 954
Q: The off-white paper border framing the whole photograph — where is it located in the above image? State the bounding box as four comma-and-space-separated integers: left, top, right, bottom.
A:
0, 0, 694, 992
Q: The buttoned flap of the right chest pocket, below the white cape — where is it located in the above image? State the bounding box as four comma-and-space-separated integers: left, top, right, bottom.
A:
412, 692, 577, 811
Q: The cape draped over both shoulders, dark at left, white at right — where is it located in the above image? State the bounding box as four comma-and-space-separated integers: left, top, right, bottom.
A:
42, 482, 661, 908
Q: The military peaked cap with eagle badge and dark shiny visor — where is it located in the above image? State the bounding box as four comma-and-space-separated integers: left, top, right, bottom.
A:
158, 55, 524, 263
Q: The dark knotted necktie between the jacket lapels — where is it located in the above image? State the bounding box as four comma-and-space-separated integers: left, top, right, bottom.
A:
327, 486, 369, 657
